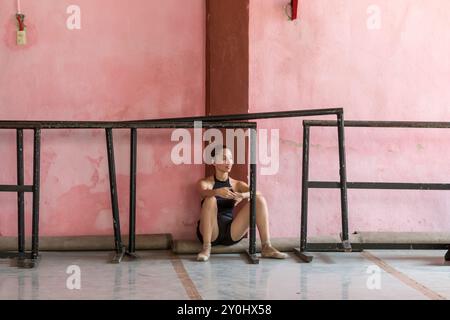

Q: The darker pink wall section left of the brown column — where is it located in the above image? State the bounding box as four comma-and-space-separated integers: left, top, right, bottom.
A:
0, 0, 205, 237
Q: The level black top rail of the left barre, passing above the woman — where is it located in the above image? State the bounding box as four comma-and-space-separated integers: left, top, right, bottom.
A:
0, 121, 257, 129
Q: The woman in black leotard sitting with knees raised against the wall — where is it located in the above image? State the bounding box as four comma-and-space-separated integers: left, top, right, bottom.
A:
197, 147, 287, 261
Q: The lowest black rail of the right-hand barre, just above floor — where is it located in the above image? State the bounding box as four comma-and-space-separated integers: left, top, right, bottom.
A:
305, 242, 450, 252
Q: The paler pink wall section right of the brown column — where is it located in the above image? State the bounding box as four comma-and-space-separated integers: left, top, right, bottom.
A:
250, 0, 450, 236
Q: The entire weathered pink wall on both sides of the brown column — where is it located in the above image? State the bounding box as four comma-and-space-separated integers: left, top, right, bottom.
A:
0, 0, 450, 238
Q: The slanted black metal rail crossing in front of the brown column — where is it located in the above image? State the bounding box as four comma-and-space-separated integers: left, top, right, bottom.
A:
123, 108, 344, 123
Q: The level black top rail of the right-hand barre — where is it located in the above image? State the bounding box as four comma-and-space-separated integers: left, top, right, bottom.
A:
303, 120, 450, 129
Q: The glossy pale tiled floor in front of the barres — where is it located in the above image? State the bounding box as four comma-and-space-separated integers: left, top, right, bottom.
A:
0, 251, 450, 300
